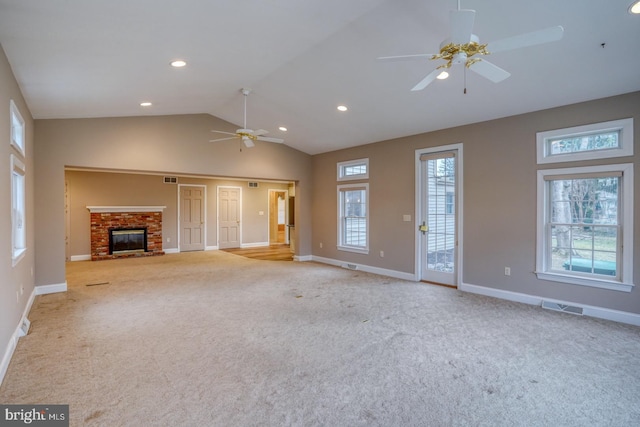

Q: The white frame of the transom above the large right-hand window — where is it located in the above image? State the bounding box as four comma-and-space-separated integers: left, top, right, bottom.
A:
536, 118, 633, 164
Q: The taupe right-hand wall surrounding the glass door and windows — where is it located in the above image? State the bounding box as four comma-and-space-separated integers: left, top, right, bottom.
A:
312, 92, 640, 313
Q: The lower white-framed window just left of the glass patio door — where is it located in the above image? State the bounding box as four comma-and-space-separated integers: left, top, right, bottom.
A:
338, 184, 369, 254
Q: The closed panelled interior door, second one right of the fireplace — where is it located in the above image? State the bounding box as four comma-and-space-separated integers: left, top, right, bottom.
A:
218, 187, 241, 249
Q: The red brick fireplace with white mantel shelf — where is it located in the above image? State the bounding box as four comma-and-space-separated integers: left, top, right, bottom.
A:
87, 206, 166, 261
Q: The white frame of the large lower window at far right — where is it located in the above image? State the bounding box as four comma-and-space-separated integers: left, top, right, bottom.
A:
536, 163, 634, 292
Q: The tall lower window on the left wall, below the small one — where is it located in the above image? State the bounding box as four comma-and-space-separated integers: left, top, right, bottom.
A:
11, 154, 27, 266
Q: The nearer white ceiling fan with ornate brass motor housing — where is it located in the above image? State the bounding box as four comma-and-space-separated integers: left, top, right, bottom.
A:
378, 0, 564, 91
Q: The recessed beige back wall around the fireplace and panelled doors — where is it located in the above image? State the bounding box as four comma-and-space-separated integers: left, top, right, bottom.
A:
65, 170, 289, 259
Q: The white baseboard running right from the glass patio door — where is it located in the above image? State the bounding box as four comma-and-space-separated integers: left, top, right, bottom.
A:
458, 283, 640, 326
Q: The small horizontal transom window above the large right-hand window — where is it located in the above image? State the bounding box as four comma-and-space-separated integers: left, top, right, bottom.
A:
537, 119, 633, 163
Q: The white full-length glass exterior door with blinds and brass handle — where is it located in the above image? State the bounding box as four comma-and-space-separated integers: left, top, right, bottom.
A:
418, 150, 458, 286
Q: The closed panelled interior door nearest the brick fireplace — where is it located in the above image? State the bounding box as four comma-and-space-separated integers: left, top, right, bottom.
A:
180, 185, 205, 252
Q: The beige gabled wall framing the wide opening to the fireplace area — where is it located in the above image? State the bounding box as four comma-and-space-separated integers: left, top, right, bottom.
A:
35, 114, 311, 285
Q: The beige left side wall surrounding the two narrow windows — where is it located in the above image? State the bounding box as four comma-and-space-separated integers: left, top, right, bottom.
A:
0, 46, 35, 374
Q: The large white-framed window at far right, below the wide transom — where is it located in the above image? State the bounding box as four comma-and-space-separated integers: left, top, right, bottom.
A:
536, 164, 633, 292
